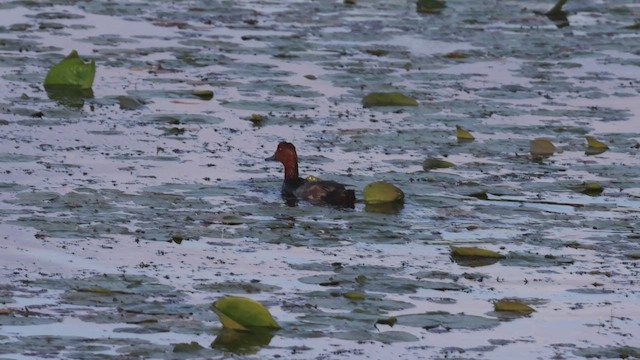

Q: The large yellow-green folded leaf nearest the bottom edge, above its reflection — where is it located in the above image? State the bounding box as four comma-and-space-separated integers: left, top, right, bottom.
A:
211, 296, 280, 331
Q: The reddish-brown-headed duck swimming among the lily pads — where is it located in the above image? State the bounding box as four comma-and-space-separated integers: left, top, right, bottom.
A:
265, 141, 356, 208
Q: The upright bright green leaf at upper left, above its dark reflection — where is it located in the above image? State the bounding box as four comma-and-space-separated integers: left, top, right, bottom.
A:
44, 50, 96, 89
